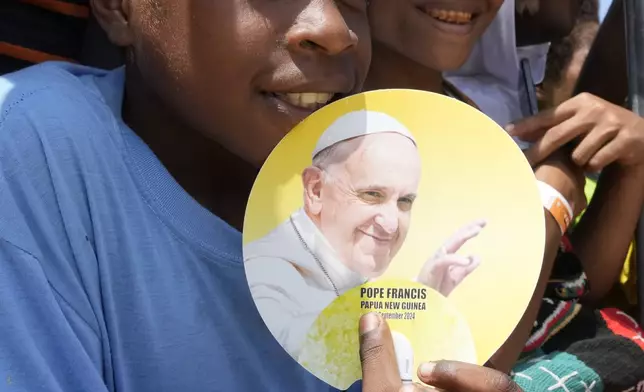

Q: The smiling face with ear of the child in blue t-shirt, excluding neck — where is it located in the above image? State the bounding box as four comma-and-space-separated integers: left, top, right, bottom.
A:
93, 0, 371, 166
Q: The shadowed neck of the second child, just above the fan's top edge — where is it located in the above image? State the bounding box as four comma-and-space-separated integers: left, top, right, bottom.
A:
365, 42, 443, 94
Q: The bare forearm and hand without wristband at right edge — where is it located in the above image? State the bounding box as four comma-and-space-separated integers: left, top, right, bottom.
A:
511, 94, 644, 300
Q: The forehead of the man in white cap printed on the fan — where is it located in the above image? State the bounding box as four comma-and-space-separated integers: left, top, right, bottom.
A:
339, 133, 421, 192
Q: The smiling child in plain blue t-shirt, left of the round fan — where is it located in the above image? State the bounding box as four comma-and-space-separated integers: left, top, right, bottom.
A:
0, 0, 370, 392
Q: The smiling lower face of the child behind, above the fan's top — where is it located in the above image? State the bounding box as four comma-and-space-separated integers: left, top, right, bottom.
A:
369, 0, 503, 71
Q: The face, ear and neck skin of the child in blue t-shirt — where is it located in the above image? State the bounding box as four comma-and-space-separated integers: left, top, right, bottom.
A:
92, 0, 371, 228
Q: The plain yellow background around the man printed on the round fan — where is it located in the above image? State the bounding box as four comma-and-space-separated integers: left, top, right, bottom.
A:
243, 90, 545, 374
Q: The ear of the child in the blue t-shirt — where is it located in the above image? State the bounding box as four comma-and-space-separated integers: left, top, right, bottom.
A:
91, 0, 133, 47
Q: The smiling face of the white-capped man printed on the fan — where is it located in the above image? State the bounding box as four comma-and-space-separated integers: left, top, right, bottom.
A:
303, 133, 421, 278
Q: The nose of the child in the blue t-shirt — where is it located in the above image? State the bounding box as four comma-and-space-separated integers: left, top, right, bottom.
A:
286, 0, 358, 55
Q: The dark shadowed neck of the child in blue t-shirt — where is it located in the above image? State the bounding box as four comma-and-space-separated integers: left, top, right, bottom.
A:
123, 67, 257, 229
